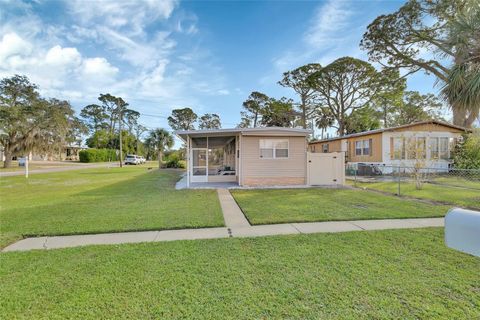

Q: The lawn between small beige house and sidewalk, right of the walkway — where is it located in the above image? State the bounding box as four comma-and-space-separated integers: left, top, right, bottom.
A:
232, 188, 449, 224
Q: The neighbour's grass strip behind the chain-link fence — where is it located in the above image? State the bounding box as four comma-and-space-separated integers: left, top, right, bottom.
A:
348, 178, 480, 209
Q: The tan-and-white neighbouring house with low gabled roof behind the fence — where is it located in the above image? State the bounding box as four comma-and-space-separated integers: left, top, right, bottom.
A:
309, 120, 467, 169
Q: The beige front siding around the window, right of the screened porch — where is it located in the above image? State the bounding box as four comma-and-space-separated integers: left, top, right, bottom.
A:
240, 135, 307, 186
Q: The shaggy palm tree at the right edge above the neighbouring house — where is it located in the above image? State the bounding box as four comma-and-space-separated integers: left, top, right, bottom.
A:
442, 5, 480, 127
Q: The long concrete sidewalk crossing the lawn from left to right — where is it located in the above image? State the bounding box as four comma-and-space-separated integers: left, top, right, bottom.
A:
2, 218, 444, 252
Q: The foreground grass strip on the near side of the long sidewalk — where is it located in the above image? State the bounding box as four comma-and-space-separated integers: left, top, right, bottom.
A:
0, 228, 480, 319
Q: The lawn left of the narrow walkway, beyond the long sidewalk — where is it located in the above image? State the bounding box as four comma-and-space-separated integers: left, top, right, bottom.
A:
0, 166, 223, 247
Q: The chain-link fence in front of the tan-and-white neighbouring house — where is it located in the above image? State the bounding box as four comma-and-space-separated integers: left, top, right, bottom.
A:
345, 163, 480, 195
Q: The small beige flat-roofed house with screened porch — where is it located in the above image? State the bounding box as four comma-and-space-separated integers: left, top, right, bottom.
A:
175, 127, 312, 187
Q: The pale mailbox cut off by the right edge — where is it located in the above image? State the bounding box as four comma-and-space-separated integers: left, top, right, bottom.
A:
445, 208, 480, 257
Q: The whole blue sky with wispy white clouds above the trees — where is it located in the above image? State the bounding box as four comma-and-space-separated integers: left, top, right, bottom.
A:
0, 0, 437, 138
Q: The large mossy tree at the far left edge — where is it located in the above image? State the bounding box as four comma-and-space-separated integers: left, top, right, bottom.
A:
0, 75, 84, 167
